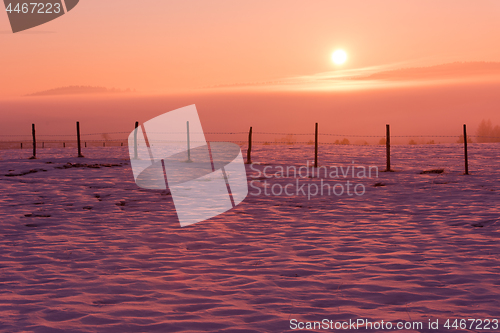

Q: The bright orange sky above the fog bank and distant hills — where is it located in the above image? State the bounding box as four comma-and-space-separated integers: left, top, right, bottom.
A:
0, 0, 500, 97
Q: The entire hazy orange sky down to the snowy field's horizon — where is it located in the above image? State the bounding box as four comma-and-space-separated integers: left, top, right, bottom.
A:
0, 0, 500, 141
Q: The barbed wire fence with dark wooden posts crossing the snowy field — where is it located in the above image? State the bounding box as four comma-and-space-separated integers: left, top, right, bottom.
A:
0, 122, 500, 174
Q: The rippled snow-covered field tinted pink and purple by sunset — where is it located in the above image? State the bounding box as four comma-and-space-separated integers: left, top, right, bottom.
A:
0, 144, 500, 333
